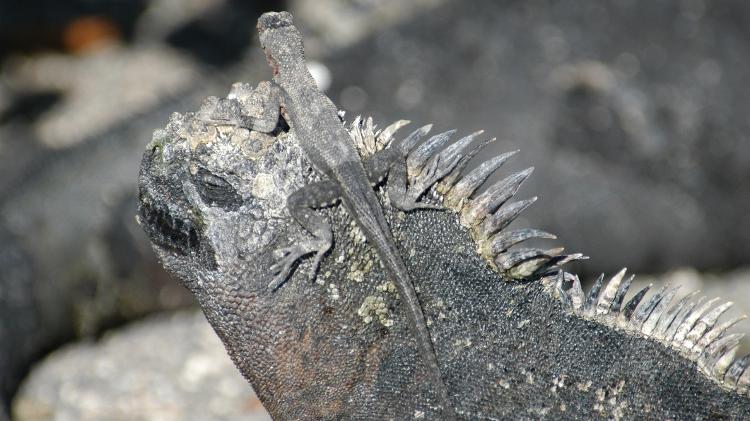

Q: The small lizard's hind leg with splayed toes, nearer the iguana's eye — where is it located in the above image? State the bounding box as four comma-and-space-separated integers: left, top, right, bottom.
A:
268, 180, 340, 290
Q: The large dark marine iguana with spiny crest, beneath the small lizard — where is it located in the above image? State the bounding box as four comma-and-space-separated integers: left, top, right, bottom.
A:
138, 11, 750, 419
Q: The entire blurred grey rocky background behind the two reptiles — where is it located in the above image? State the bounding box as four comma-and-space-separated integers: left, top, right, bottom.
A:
0, 0, 750, 419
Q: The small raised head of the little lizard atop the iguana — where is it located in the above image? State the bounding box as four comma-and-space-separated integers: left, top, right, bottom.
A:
257, 12, 304, 75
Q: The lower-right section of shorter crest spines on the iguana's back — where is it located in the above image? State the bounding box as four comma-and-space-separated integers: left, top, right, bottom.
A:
542, 269, 750, 394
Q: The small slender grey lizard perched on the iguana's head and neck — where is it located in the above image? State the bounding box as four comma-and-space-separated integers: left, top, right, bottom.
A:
252, 12, 453, 418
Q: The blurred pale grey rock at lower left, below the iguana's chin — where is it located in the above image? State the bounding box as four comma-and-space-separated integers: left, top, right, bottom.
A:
13, 312, 270, 421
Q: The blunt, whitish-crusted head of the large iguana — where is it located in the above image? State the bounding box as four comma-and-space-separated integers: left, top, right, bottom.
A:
137, 83, 304, 292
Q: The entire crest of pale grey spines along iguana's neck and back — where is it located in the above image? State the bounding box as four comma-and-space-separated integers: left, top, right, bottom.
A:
349, 117, 750, 395
